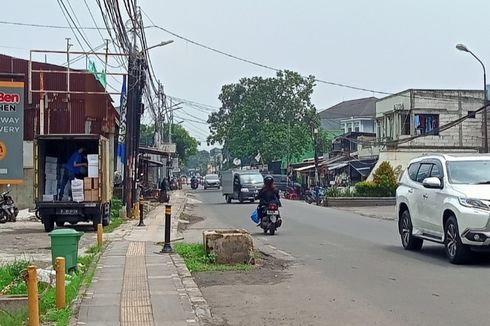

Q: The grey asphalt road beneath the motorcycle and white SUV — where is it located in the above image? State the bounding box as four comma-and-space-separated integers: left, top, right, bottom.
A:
187, 190, 490, 325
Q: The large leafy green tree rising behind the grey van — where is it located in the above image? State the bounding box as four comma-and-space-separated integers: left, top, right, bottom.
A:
208, 71, 320, 161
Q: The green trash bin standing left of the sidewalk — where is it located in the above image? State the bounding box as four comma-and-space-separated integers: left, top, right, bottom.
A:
49, 229, 83, 272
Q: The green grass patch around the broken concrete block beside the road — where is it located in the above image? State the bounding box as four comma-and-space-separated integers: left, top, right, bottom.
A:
174, 243, 253, 272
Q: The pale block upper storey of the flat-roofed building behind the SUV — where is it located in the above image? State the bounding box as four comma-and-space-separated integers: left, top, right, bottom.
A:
376, 89, 483, 150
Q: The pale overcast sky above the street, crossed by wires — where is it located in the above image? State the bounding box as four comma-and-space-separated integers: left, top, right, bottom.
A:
0, 0, 490, 148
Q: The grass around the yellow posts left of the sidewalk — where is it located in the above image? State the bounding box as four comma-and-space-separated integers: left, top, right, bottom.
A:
0, 246, 100, 326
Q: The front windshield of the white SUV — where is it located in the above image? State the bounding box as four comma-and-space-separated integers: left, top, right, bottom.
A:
447, 160, 490, 184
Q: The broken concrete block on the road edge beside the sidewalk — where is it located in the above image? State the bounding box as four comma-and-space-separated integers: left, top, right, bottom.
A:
203, 229, 254, 264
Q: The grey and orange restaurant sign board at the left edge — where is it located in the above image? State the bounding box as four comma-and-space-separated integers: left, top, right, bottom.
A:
0, 81, 24, 184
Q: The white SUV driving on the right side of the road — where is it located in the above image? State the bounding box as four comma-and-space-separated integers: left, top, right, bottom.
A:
396, 154, 490, 264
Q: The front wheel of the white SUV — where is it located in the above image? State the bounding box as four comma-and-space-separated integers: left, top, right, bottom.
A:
444, 215, 471, 264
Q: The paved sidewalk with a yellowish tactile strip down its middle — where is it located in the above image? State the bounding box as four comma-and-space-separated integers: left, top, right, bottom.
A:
76, 192, 209, 326
